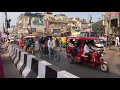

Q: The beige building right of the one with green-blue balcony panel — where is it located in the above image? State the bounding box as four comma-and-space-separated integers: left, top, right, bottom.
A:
44, 14, 70, 36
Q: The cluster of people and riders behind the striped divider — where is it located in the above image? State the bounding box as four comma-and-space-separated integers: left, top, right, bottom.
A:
15, 36, 60, 57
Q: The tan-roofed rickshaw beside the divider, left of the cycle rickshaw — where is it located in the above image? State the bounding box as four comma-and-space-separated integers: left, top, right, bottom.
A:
24, 36, 36, 54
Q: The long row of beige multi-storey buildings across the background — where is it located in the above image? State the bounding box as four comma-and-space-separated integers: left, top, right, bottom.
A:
16, 13, 88, 36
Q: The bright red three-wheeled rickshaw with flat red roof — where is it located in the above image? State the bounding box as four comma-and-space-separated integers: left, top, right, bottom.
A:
66, 37, 109, 72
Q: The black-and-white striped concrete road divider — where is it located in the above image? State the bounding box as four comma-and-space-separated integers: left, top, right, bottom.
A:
9, 45, 80, 78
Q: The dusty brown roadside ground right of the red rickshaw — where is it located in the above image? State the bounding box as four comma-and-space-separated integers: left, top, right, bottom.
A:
104, 46, 120, 75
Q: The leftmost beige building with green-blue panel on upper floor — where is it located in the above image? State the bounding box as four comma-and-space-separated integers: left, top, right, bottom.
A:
16, 13, 45, 35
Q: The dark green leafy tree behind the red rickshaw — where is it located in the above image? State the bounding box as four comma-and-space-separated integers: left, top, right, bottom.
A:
92, 20, 105, 33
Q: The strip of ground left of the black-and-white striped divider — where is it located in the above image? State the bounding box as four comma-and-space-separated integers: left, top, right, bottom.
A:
1, 46, 22, 78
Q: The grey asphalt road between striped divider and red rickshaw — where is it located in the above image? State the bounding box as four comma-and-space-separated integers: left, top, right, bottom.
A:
35, 46, 120, 78
